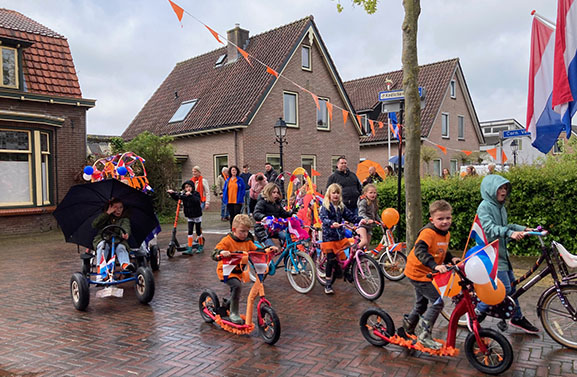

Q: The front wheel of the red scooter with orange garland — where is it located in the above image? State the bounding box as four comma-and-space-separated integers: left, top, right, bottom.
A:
465, 328, 513, 374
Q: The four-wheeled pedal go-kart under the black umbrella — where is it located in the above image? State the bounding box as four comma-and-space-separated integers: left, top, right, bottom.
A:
70, 225, 154, 311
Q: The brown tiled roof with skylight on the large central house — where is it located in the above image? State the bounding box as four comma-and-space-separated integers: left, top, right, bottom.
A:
122, 16, 313, 139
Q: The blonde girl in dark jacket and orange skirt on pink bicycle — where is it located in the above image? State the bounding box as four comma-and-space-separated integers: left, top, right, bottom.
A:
319, 183, 365, 295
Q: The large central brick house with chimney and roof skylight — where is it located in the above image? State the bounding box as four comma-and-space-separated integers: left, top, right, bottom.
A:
122, 16, 360, 200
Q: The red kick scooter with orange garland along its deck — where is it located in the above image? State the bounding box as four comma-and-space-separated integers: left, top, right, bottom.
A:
360, 264, 513, 374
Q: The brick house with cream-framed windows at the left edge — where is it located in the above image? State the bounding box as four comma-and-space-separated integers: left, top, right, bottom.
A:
0, 9, 95, 234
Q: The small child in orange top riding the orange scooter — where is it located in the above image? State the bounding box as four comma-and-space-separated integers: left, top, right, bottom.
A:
212, 214, 258, 324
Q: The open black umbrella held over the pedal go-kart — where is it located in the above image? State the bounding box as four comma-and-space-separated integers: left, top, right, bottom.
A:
54, 179, 159, 248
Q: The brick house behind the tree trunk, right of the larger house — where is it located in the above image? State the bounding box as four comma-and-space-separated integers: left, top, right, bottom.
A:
345, 58, 484, 175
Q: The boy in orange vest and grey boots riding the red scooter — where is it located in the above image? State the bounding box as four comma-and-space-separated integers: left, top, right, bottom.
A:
403, 200, 460, 349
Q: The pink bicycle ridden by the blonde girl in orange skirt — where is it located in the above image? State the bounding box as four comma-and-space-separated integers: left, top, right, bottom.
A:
310, 223, 385, 301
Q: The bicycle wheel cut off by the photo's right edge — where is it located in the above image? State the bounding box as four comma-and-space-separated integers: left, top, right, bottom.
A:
537, 285, 577, 349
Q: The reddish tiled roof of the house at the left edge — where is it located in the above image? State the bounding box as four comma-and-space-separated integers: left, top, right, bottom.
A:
0, 9, 82, 98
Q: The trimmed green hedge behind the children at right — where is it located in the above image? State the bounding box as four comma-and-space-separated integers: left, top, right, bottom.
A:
378, 157, 577, 255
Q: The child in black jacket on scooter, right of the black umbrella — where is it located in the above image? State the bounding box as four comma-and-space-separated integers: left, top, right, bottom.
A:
167, 180, 204, 255
